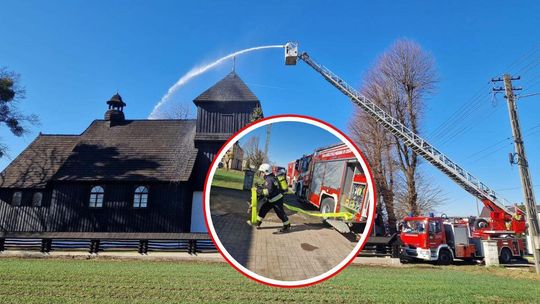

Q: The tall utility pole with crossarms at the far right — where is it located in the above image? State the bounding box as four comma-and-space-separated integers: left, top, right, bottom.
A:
491, 74, 540, 274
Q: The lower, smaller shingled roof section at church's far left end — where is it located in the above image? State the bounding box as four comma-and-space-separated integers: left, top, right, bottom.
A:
0, 134, 79, 188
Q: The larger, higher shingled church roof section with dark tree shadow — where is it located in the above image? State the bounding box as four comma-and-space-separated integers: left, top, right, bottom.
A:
54, 120, 197, 182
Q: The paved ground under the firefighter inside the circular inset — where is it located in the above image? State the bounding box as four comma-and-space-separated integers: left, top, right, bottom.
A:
210, 187, 356, 281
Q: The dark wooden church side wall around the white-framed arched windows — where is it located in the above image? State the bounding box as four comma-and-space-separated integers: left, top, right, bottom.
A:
0, 183, 192, 232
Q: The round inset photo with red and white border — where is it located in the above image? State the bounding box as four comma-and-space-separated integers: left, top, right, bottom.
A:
204, 115, 375, 287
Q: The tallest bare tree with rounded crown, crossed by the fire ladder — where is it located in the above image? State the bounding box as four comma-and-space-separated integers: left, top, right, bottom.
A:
377, 39, 437, 214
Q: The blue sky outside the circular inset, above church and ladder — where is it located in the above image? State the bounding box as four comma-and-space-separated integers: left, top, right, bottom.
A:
0, 0, 540, 215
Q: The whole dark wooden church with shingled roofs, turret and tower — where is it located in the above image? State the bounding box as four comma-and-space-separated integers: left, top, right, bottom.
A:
0, 72, 260, 238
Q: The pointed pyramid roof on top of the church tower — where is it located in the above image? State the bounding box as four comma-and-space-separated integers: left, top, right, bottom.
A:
193, 72, 259, 103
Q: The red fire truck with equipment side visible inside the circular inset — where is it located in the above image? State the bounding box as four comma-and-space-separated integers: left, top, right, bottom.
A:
294, 143, 369, 223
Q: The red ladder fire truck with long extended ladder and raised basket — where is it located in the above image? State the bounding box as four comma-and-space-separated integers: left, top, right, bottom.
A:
285, 42, 526, 264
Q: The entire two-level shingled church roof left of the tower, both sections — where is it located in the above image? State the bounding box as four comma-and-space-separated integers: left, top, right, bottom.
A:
0, 120, 197, 188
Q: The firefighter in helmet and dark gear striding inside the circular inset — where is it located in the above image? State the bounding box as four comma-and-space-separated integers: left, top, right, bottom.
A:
248, 164, 291, 233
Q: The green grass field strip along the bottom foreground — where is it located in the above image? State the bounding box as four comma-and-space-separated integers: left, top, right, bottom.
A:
0, 258, 540, 304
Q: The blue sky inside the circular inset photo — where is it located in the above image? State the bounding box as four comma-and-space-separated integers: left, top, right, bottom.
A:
240, 121, 341, 168
